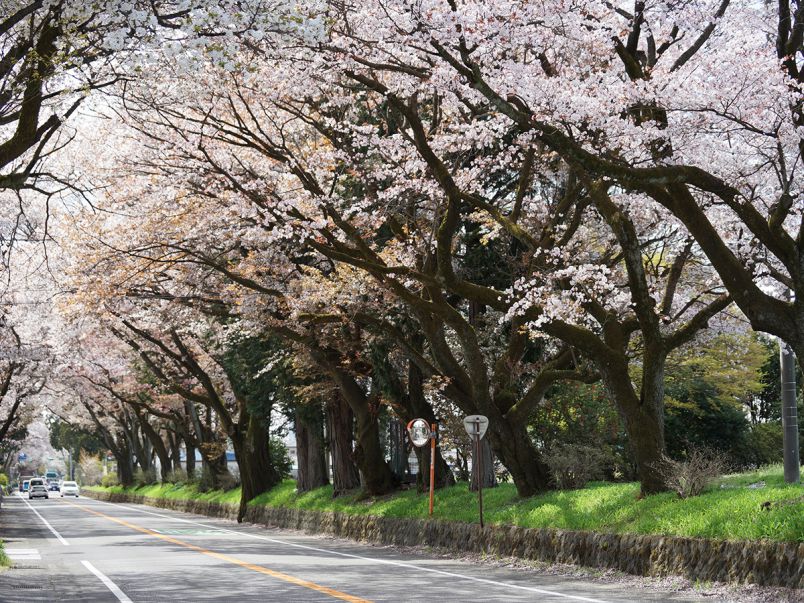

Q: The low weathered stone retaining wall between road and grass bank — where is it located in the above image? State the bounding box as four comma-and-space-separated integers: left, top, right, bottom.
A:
85, 490, 804, 588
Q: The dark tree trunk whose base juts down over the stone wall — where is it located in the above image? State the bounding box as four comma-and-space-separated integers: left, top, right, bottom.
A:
232, 412, 281, 523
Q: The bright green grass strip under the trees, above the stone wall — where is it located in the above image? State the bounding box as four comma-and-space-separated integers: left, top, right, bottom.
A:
85, 467, 804, 542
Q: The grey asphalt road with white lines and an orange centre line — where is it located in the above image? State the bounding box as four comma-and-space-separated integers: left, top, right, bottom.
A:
0, 496, 712, 603
